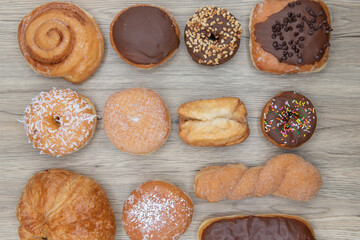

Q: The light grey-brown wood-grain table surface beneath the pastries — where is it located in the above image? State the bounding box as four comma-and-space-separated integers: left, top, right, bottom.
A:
0, 0, 360, 240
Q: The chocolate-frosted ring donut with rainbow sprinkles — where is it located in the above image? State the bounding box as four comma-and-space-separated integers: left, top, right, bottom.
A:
261, 91, 317, 148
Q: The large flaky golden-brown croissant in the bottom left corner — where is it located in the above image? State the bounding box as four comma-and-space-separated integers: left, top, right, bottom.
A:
16, 169, 116, 240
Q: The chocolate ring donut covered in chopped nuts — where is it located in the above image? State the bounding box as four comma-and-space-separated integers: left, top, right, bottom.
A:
184, 6, 243, 66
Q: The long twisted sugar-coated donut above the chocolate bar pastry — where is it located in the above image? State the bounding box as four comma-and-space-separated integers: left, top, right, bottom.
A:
194, 154, 322, 202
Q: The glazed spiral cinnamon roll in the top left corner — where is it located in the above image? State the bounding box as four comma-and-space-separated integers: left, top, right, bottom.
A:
18, 2, 104, 83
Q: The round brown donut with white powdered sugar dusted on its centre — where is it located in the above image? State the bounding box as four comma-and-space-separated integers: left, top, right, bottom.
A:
122, 180, 193, 240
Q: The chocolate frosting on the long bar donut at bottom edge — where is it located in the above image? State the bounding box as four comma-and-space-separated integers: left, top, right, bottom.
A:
201, 216, 315, 240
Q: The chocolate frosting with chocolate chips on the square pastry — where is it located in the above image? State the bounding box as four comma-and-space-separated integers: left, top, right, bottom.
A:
255, 0, 332, 65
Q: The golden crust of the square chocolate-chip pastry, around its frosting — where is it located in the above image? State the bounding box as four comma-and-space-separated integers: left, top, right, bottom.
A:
249, 0, 331, 74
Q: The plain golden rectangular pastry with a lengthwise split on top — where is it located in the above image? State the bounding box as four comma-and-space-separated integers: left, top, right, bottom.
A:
177, 97, 250, 147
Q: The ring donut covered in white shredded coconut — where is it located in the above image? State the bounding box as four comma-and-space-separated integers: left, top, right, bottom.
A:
23, 89, 97, 157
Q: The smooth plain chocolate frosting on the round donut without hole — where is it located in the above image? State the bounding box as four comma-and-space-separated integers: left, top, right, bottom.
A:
112, 5, 180, 64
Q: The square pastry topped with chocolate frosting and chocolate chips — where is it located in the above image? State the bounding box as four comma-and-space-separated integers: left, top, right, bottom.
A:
250, 0, 332, 74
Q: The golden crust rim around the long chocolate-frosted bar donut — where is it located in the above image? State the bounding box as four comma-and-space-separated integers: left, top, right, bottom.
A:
198, 214, 315, 240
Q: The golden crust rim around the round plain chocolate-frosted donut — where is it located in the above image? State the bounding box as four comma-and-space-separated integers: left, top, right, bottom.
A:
109, 4, 180, 69
